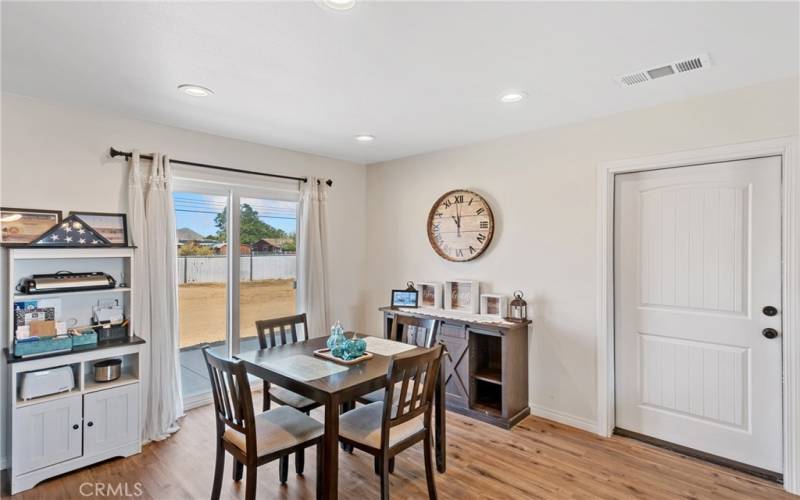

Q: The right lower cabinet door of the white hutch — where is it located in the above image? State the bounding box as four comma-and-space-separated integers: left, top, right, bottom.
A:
83, 384, 140, 456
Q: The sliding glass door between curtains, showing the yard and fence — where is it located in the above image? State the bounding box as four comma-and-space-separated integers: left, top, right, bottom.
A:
173, 181, 297, 406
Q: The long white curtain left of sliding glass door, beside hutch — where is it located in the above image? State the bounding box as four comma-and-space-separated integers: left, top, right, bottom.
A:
128, 152, 183, 441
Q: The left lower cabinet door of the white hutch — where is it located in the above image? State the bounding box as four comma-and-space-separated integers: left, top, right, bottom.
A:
11, 394, 81, 476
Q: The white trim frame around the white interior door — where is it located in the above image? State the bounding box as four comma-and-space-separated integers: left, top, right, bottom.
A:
597, 136, 800, 495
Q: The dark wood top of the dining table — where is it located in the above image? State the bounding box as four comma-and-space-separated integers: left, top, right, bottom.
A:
235, 337, 406, 402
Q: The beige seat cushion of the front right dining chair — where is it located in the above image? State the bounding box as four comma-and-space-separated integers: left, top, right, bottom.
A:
339, 402, 424, 448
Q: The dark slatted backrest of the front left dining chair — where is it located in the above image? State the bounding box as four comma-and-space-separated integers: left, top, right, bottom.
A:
203, 346, 256, 451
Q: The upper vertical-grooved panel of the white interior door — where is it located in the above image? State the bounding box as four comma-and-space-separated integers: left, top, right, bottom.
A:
639, 183, 750, 314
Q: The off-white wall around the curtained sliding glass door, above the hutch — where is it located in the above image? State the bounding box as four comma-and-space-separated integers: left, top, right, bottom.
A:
0, 94, 366, 468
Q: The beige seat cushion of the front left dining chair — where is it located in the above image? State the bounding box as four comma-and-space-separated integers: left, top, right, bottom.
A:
222, 406, 325, 457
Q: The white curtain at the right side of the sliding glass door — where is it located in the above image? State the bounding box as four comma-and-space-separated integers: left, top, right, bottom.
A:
297, 177, 331, 338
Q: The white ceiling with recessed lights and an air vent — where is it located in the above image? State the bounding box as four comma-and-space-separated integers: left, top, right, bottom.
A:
2, 1, 800, 163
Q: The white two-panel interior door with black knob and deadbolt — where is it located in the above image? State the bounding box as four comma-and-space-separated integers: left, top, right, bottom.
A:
614, 157, 782, 472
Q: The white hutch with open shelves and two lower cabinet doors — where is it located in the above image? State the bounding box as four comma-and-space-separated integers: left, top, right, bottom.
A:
0, 247, 145, 494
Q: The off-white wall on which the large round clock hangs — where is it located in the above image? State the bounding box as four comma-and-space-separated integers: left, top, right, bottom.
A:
364, 79, 800, 429
